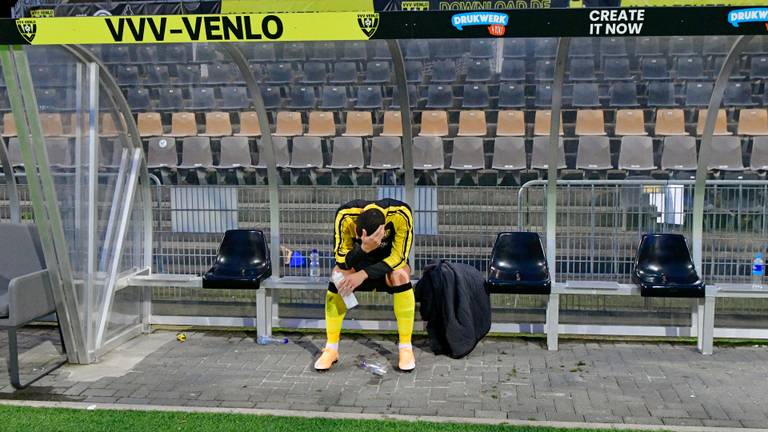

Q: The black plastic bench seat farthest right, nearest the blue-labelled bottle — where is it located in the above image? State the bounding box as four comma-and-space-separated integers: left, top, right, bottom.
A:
632, 234, 705, 298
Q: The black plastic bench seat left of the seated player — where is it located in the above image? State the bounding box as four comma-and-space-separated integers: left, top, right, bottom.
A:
203, 229, 272, 289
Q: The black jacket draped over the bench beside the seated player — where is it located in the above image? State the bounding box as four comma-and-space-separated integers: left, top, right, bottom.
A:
416, 261, 491, 358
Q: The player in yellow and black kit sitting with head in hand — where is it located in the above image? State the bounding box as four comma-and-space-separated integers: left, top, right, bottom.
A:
315, 199, 416, 371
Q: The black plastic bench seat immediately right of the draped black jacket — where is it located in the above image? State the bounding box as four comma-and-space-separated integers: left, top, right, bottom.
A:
485, 232, 552, 294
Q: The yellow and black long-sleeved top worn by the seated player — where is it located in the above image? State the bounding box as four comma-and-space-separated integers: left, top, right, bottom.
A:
334, 198, 413, 279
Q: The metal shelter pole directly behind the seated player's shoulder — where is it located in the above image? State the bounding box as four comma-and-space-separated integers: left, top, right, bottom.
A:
387, 40, 416, 267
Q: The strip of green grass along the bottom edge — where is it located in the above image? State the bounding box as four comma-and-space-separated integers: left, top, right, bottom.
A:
0, 406, 652, 432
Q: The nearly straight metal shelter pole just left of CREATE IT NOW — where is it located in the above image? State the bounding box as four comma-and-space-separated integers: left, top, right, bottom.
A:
547, 38, 571, 284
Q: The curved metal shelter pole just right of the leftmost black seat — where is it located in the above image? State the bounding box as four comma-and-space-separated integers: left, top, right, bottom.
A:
222, 44, 281, 278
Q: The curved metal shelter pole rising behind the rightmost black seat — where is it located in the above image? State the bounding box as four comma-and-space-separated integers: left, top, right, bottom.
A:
691, 36, 753, 275
